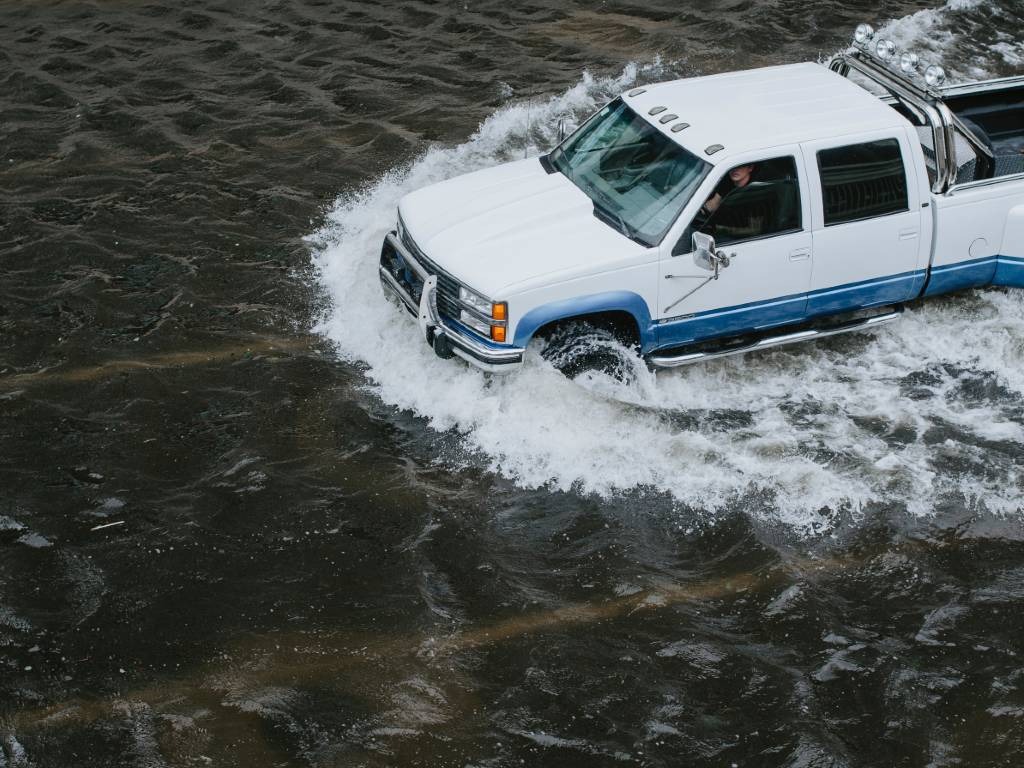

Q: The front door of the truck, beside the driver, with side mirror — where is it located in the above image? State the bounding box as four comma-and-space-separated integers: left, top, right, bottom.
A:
656, 147, 812, 347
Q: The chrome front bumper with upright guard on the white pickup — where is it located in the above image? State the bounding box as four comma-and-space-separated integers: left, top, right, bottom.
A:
378, 232, 523, 374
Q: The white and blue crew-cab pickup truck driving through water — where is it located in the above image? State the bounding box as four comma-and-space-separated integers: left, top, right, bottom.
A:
379, 25, 1024, 372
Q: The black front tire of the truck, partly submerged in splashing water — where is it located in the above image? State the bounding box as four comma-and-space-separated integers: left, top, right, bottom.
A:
541, 321, 643, 383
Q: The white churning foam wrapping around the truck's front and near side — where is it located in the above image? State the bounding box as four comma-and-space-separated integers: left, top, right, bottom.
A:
311, 34, 1024, 529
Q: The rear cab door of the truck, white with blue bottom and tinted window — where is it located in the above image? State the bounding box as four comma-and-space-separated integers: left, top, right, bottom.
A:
803, 131, 929, 315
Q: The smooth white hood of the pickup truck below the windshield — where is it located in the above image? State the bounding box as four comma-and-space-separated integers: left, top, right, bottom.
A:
398, 159, 646, 299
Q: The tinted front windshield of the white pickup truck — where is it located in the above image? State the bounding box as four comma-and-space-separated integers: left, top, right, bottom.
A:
548, 99, 711, 246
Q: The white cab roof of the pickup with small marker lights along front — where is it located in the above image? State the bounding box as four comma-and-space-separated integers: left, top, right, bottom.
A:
624, 63, 907, 165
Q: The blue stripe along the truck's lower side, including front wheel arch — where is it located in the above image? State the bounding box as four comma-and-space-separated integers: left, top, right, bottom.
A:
514, 256, 1024, 353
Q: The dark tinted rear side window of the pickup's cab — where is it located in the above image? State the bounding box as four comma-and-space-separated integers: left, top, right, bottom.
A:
818, 138, 908, 226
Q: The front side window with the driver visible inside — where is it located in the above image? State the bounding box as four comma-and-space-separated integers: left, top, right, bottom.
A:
674, 156, 803, 253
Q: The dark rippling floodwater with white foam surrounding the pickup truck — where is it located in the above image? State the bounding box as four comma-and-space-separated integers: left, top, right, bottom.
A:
0, 0, 1024, 768
